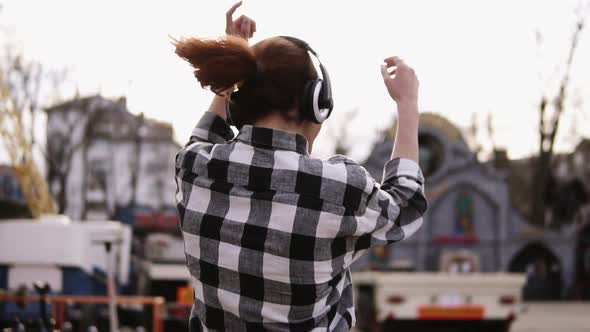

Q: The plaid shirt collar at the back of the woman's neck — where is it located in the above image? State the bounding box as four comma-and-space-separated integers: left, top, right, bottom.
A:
236, 125, 308, 155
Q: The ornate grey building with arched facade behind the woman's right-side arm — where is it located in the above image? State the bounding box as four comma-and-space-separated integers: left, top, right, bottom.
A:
356, 113, 590, 299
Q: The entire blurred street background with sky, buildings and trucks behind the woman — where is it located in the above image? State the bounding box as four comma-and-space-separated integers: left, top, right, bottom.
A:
0, 0, 590, 331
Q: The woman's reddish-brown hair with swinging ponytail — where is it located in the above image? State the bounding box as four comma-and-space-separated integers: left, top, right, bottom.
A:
175, 36, 317, 124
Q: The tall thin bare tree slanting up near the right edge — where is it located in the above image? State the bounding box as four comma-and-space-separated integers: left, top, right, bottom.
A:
530, 15, 585, 226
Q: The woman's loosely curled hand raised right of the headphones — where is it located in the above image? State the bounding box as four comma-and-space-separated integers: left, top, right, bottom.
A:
381, 56, 420, 106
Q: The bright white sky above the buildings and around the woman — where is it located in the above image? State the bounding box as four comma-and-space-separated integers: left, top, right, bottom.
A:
0, 0, 590, 160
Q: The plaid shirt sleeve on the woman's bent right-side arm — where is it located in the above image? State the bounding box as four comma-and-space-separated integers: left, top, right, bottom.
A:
357, 158, 428, 246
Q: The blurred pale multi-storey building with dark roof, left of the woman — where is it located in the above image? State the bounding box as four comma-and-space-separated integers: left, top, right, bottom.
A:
46, 96, 180, 227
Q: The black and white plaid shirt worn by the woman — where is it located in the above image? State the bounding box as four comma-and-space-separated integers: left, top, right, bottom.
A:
176, 112, 427, 331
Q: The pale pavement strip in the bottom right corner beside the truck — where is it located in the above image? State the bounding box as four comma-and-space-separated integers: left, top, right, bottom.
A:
510, 302, 590, 332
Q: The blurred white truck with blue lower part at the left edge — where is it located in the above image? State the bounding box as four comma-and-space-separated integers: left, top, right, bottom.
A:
0, 215, 132, 328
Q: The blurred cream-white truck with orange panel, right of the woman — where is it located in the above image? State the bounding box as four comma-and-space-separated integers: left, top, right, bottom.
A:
352, 271, 525, 331
